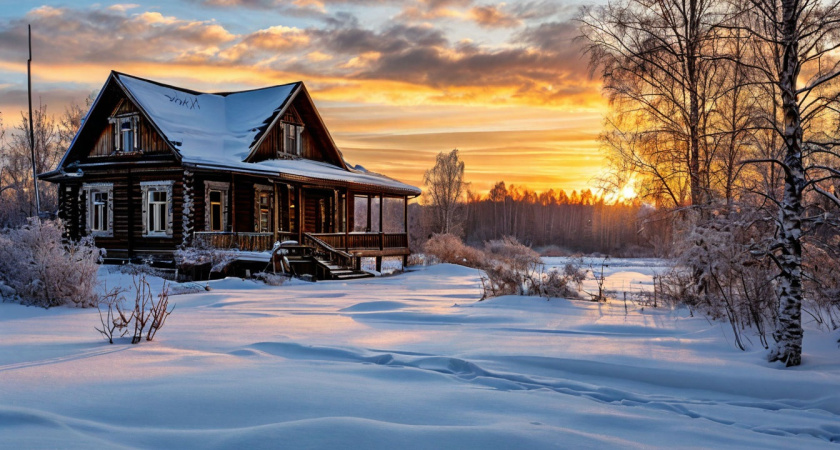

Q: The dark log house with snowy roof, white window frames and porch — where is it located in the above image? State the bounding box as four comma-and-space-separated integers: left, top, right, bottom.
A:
40, 72, 420, 278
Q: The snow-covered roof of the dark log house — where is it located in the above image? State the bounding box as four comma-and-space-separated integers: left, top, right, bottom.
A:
114, 72, 420, 195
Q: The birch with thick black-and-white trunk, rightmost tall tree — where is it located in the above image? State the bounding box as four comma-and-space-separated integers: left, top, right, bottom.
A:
744, 0, 840, 366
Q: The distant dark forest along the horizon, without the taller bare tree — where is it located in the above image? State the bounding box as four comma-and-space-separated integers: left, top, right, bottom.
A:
409, 182, 656, 256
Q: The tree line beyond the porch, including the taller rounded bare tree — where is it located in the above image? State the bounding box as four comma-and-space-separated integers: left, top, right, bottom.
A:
410, 149, 659, 255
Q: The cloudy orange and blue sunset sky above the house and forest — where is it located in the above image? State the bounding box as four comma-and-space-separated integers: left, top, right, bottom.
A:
0, 0, 605, 193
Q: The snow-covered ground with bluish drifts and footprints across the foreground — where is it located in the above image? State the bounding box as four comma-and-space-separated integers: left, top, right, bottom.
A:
0, 264, 840, 449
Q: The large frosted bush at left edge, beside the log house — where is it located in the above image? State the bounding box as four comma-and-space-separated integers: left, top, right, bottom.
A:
0, 219, 101, 308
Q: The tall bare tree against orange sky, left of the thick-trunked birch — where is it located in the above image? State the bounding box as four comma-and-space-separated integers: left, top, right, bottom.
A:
579, 0, 721, 206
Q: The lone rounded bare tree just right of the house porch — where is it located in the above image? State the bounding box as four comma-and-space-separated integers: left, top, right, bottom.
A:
423, 148, 466, 234
